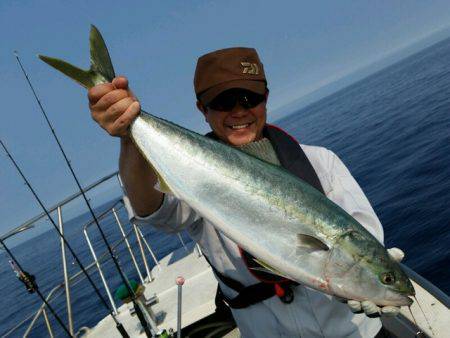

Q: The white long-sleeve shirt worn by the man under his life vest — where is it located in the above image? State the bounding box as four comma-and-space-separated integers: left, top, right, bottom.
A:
125, 145, 383, 338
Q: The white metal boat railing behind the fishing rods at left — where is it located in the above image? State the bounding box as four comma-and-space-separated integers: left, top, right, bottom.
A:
2, 172, 197, 337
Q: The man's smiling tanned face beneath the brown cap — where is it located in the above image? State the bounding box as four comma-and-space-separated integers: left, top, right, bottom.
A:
197, 90, 268, 146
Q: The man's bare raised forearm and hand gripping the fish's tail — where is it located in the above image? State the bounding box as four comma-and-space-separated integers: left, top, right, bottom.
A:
88, 77, 163, 216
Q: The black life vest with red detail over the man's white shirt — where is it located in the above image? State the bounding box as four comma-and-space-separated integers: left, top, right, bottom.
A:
205, 124, 325, 309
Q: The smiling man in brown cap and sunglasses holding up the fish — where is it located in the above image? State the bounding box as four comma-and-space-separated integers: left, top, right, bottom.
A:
89, 48, 401, 337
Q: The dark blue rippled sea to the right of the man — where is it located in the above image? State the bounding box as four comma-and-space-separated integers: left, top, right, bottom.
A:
279, 39, 450, 294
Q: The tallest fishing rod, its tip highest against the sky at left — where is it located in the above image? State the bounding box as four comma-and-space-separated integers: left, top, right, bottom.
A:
14, 51, 153, 337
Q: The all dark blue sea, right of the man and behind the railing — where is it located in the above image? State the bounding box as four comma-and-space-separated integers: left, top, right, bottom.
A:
0, 39, 450, 337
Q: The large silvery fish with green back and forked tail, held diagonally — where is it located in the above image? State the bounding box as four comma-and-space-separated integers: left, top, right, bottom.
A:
39, 25, 415, 306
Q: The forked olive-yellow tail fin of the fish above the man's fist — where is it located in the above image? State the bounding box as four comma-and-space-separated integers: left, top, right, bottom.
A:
38, 25, 115, 89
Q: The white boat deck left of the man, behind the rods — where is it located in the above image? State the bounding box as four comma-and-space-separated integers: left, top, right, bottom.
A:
86, 243, 217, 338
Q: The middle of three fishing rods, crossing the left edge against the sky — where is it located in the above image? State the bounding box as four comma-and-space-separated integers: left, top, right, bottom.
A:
0, 140, 129, 338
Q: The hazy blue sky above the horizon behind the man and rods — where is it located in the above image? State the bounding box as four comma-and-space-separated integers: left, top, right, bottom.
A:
0, 0, 450, 242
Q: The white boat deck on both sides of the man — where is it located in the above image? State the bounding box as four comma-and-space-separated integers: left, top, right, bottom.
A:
87, 243, 450, 338
